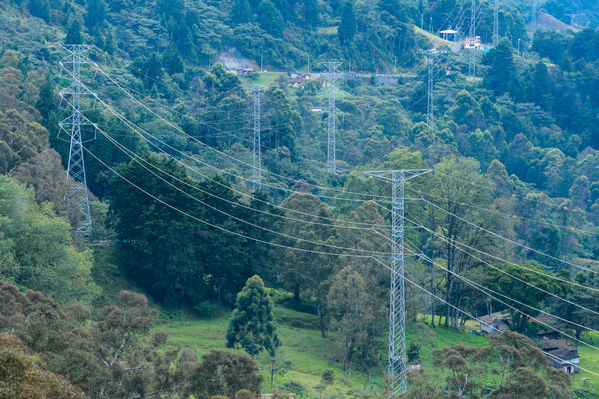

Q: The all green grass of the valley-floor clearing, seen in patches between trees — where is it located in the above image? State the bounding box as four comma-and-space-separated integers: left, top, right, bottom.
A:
92, 250, 599, 398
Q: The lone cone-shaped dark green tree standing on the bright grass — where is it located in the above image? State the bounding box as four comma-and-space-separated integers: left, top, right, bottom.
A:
227, 276, 281, 357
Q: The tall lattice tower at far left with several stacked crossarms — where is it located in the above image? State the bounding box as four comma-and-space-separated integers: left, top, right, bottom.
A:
59, 44, 96, 237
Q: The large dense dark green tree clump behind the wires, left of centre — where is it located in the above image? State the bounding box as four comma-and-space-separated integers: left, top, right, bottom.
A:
110, 155, 250, 304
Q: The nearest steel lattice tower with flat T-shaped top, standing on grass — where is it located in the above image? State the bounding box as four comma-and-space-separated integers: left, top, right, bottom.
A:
364, 169, 432, 398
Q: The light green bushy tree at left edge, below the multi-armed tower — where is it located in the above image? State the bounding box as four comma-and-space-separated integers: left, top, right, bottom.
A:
0, 176, 100, 303
